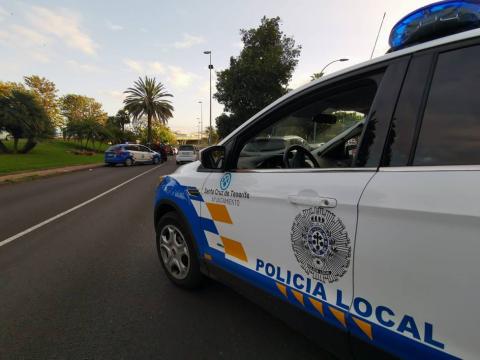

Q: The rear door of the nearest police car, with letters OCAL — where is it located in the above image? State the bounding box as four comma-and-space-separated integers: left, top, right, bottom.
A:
352, 40, 480, 359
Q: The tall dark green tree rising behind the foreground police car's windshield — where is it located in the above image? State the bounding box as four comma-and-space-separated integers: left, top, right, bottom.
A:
214, 17, 301, 138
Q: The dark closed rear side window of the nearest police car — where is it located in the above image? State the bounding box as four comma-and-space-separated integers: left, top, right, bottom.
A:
413, 46, 480, 166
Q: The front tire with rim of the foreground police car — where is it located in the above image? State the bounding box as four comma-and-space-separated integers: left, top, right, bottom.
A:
156, 211, 204, 289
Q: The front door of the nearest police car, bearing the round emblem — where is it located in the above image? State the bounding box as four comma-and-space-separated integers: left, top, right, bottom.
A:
201, 60, 406, 352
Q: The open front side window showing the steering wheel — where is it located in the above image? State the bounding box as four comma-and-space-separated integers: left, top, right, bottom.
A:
237, 78, 377, 169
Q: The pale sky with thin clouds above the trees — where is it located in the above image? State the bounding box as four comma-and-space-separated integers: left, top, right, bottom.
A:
0, 0, 432, 132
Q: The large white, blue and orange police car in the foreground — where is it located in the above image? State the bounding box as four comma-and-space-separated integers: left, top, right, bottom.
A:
155, 1, 480, 359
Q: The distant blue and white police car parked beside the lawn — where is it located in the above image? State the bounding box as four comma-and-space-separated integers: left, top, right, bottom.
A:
105, 144, 161, 166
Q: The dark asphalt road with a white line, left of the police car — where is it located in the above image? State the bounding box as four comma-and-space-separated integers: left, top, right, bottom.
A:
0, 160, 326, 360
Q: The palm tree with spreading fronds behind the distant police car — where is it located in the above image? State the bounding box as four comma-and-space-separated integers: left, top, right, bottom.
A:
123, 76, 173, 143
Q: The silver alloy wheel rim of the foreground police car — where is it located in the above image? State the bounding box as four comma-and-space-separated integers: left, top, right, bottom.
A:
160, 225, 190, 280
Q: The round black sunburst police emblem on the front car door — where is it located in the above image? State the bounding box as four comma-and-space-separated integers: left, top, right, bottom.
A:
290, 207, 352, 283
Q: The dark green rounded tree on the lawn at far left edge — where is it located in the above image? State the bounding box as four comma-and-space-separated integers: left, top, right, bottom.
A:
0, 89, 53, 153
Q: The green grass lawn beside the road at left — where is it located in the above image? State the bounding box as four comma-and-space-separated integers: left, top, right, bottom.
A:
0, 140, 108, 175
